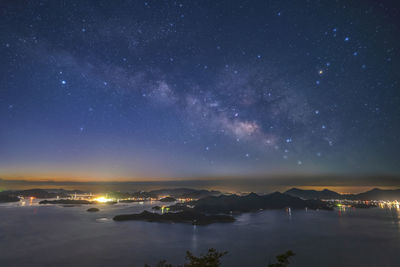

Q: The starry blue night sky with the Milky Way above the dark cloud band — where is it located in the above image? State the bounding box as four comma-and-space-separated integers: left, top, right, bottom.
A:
0, 0, 400, 180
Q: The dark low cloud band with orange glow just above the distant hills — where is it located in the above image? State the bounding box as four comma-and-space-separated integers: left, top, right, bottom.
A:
0, 174, 400, 194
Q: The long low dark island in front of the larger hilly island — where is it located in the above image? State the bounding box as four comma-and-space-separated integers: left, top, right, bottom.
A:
113, 211, 235, 225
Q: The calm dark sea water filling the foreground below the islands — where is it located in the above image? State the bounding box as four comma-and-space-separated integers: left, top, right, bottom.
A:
0, 202, 400, 266
